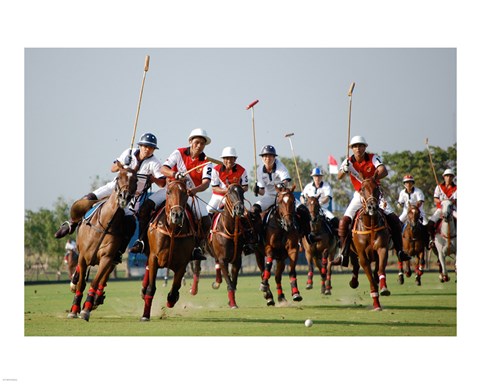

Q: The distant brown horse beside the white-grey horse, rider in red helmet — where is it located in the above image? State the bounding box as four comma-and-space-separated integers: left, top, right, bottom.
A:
398, 204, 427, 285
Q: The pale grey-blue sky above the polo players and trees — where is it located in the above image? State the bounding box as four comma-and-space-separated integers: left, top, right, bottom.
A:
25, 48, 457, 210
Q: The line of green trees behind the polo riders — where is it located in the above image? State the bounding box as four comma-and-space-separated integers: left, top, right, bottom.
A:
24, 144, 457, 269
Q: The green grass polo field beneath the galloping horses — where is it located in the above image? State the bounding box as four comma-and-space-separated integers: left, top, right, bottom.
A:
25, 272, 457, 336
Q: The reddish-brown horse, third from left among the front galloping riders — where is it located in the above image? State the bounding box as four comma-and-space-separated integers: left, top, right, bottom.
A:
207, 183, 246, 309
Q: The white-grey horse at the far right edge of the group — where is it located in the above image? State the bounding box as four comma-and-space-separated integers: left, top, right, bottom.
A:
435, 200, 457, 283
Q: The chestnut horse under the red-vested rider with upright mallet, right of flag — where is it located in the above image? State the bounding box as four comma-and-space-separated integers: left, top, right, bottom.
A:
350, 178, 390, 311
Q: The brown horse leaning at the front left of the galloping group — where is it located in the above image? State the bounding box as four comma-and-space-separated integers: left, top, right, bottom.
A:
68, 168, 137, 321
